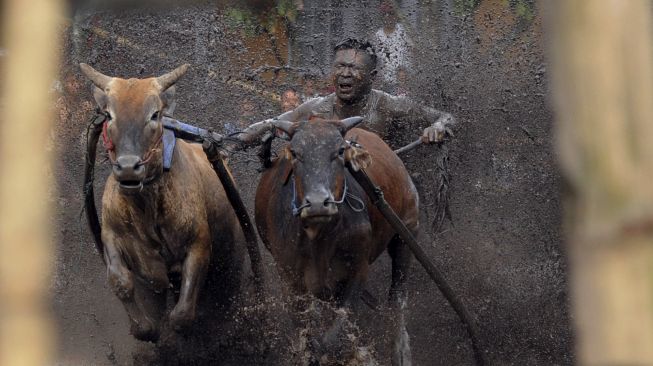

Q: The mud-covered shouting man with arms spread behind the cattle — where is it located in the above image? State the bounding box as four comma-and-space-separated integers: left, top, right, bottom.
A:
234, 38, 454, 150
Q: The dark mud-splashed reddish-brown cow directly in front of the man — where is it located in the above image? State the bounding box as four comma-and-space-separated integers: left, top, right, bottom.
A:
256, 117, 418, 365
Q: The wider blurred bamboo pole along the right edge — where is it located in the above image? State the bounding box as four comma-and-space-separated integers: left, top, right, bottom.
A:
549, 0, 653, 365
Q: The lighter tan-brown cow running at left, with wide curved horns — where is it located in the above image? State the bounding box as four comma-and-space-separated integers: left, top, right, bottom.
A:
80, 64, 244, 341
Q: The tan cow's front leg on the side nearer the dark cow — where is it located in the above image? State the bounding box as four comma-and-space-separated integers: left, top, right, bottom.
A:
170, 239, 211, 331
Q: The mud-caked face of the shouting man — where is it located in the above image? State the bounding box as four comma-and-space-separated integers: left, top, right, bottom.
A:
332, 49, 372, 103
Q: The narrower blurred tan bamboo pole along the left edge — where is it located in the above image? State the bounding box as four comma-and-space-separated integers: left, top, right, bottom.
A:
0, 0, 63, 366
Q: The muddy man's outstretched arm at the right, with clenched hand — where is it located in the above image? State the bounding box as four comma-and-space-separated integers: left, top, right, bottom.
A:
382, 93, 456, 143
